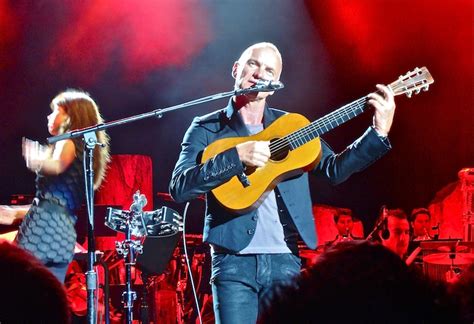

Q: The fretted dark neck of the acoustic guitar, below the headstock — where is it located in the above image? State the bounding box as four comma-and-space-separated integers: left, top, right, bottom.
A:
285, 96, 368, 149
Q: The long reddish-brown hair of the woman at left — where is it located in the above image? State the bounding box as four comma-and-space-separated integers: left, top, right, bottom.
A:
50, 89, 110, 189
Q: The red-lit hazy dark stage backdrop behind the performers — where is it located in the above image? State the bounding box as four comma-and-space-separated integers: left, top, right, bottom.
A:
0, 0, 474, 232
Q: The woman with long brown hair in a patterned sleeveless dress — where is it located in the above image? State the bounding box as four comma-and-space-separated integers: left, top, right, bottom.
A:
0, 89, 109, 282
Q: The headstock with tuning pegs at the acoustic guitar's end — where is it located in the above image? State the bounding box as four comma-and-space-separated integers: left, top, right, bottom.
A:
389, 67, 434, 98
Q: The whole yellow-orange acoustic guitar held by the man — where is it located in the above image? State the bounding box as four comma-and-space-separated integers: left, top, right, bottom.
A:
201, 67, 434, 214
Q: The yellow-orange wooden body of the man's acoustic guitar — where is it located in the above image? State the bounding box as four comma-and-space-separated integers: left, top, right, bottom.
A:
202, 114, 322, 214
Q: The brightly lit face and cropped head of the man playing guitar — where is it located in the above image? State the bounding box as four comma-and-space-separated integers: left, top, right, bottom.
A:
232, 47, 282, 100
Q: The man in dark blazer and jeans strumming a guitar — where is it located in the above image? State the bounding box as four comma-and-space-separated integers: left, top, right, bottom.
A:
170, 43, 395, 323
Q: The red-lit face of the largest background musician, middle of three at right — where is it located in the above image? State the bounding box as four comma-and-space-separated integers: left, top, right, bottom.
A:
382, 216, 410, 257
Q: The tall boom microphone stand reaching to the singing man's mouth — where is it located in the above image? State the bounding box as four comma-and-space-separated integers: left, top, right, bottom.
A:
47, 81, 284, 324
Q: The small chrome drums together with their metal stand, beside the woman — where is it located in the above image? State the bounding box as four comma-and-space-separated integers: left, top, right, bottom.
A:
105, 190, 183, 323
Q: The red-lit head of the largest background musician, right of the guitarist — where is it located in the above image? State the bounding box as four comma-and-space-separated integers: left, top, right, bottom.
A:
379, 209, 410, 259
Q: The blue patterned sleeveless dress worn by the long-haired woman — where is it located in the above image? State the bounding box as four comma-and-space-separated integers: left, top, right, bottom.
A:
16, 151, 84, 264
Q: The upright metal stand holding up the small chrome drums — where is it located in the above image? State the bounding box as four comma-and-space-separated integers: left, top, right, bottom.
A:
115, 211, 143, 324
